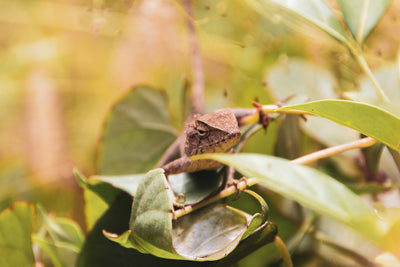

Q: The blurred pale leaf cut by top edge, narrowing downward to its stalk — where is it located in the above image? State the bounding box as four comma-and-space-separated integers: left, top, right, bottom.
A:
337, 0, 391, 43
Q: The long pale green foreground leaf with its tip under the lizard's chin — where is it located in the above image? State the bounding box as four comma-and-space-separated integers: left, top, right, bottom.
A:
193, 154, 399, 254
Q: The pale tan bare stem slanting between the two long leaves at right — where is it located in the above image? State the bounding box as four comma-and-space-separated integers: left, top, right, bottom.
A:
292, 137, 376, 164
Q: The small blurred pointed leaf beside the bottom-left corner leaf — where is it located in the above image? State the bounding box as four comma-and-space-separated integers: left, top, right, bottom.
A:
37, 205, 84, 252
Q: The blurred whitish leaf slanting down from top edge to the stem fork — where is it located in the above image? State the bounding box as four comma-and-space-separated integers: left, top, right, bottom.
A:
248, 0, 347, 42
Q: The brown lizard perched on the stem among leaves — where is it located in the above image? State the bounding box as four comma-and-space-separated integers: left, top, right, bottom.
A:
158, 109, 256, 176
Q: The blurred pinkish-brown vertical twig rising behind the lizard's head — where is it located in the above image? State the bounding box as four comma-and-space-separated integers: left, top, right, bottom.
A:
183, 0, 204, 114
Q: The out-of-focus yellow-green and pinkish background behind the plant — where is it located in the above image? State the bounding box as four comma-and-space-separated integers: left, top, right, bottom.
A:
0, 0, 400, 234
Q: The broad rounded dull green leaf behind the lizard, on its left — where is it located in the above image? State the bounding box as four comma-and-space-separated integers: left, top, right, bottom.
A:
99, 87, 177, 175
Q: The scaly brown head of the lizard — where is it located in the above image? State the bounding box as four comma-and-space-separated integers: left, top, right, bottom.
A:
184, 110, 240, 156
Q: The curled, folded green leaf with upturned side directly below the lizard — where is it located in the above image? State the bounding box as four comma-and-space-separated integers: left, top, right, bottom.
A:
105, 169, 266, 261
